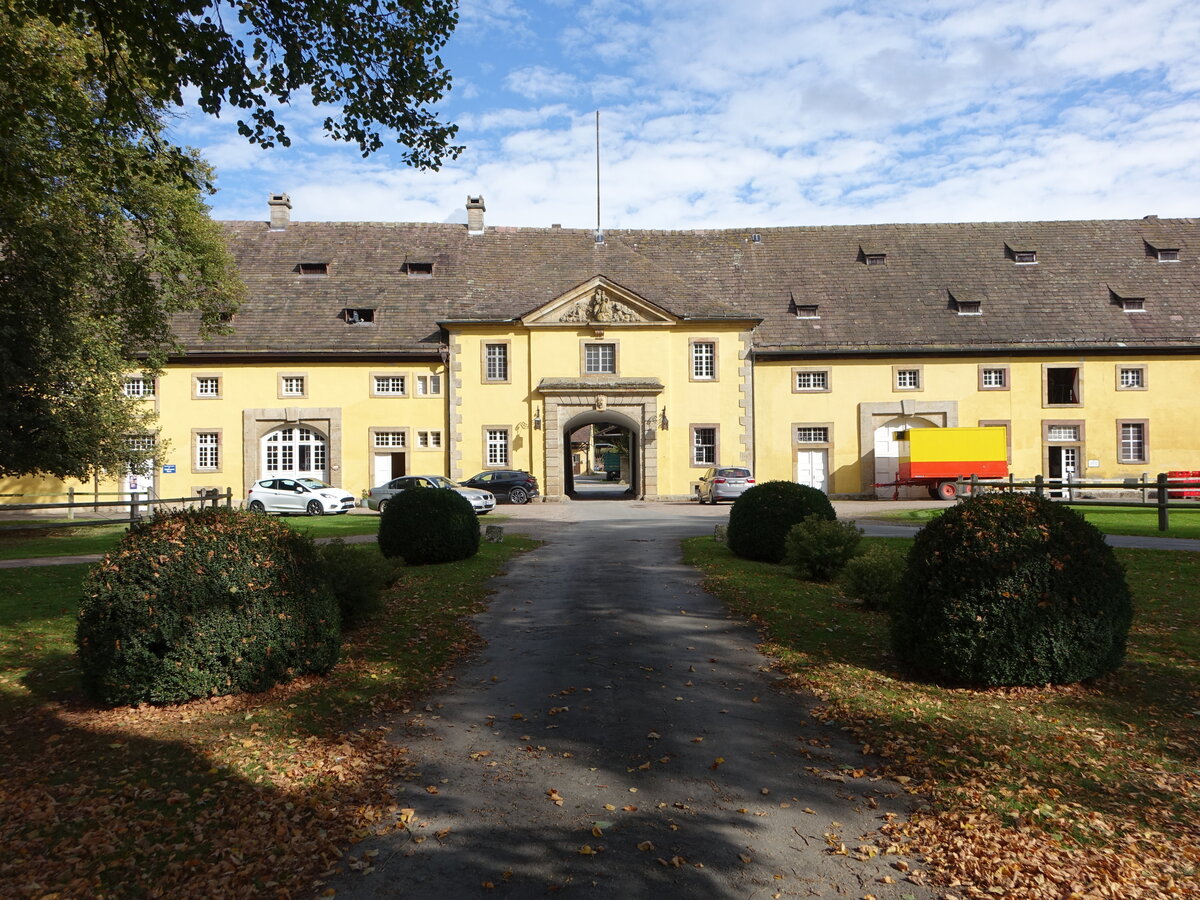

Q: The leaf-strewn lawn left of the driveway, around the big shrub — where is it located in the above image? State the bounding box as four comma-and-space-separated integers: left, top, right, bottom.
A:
0, 535, 535, 896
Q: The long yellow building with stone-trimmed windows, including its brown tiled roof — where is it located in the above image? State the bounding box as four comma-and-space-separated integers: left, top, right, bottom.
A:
0, 194, 1200, 500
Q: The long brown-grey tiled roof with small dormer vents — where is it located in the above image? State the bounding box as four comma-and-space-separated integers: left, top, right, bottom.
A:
179, 218, 1200, 356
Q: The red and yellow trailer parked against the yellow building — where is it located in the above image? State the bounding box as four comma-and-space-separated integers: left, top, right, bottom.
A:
896, 426, 1008, 500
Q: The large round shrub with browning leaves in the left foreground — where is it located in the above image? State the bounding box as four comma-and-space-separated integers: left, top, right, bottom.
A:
76, 509, 341, 706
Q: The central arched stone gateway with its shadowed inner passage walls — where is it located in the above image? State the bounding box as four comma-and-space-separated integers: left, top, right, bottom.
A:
538, 378, 662, 499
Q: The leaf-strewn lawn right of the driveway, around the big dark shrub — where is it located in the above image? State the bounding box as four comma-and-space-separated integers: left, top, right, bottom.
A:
684, 538, 1200, 896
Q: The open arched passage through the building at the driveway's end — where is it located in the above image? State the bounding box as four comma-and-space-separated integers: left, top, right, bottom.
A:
563, 409, 642, 500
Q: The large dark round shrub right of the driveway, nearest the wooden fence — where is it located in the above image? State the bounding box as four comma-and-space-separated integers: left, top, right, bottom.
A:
890, 494, 1133, 686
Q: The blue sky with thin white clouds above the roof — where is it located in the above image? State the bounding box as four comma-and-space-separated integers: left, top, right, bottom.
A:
176, 0, 1200, 228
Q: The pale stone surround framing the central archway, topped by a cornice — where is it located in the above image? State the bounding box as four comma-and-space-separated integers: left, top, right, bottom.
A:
540, 384, 662, 500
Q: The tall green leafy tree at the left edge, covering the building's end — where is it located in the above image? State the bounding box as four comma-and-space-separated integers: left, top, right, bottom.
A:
0, 14, 241, 478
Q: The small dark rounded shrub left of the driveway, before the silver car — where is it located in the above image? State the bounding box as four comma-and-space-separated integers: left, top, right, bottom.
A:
379, 487, 479, 565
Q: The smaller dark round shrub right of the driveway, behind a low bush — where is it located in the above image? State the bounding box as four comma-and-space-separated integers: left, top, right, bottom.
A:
727, 481, 838, 563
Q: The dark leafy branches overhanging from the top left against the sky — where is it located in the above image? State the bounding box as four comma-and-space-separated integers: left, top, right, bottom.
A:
24, 0, 461, 169
